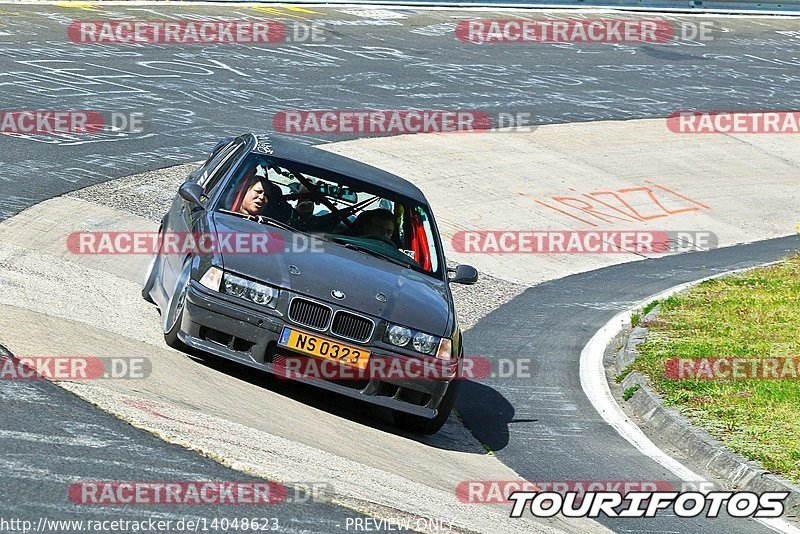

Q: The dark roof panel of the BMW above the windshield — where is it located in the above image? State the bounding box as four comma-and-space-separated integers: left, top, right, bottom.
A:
245, 134, 428, 206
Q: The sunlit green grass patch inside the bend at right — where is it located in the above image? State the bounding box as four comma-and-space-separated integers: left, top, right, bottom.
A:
631, 256, 800, 483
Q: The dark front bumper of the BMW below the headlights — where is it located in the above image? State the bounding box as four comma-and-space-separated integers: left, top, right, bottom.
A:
183, 281, 450, 419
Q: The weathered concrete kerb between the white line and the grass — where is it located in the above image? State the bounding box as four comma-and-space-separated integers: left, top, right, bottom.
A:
613, 272, 800, 525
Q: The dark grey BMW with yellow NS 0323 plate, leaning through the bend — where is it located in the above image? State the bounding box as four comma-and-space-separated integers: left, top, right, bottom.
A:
142, 134, 478, 434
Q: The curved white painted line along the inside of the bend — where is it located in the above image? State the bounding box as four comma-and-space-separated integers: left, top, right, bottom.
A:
580, 262, 800, 534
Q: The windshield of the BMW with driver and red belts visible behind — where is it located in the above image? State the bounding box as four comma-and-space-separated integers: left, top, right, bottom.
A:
217, 153, 441, 276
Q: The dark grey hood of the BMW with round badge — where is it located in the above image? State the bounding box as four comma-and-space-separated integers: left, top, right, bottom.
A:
214, 214, 451, 336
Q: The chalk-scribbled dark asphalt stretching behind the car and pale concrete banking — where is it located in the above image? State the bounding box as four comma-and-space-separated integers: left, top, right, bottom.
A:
0, 4, 800, 219
